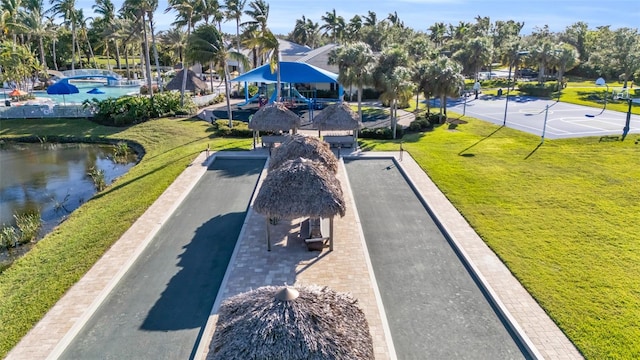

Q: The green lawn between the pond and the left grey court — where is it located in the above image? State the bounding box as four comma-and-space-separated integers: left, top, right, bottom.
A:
0, 119, 251, 357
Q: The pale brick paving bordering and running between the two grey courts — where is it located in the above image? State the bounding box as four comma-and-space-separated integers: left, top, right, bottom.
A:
7, 150, 582, 359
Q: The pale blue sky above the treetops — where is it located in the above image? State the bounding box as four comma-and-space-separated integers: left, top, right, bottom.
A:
76, 0, 640, 35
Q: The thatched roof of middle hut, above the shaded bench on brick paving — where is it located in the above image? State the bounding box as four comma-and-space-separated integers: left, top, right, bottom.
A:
253, 158, 345, 219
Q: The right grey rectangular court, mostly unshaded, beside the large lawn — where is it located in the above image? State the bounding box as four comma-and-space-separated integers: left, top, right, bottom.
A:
345, 158, 530, 359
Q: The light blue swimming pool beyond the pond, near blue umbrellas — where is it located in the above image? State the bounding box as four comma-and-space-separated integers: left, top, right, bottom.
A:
33, 80, 140, 105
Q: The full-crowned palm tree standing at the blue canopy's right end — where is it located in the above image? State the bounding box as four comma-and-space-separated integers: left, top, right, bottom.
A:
329, 42, 375, 121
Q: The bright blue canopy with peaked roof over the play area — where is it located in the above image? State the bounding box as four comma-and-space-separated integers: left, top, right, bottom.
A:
231, 61, 343, 109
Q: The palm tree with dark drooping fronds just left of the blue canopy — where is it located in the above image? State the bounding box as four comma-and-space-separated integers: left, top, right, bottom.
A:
187, 24, 248, 127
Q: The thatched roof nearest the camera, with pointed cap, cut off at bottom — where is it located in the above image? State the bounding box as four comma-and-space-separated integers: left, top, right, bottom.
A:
207, 286, 374, 360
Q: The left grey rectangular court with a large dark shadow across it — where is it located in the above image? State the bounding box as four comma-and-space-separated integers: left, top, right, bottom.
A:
60, 159, 265, 359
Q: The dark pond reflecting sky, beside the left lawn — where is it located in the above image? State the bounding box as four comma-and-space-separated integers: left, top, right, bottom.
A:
0, 143, 138, 240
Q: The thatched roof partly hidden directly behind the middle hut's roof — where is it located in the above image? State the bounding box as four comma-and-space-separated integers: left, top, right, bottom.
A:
269, 134, 338, 174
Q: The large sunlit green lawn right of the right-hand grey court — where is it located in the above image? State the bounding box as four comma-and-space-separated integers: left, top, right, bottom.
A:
361, 118, 640, 359
